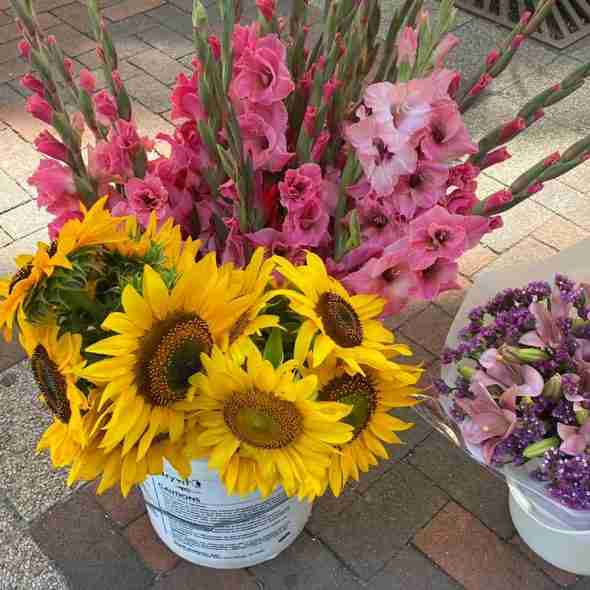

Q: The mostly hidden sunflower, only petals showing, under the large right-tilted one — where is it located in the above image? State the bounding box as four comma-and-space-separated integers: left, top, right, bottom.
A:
67, 390, 191, 497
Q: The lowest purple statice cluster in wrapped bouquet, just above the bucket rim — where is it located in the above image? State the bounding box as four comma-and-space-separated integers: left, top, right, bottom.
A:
533, 449, 590, 510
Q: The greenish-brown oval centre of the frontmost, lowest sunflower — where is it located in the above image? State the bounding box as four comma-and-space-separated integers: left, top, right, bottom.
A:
223, 390, 303, 449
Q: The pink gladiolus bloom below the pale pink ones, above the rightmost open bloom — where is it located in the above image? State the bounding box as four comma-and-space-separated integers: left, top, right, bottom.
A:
393, 160, 449, 220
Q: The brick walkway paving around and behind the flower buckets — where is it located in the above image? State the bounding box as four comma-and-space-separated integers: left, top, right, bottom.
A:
0, 0, 590, 590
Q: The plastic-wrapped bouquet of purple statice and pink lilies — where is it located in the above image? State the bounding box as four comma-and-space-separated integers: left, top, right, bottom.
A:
421, 242, 590, 530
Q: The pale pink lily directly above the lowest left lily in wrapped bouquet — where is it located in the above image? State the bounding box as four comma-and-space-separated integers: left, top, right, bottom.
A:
473, 348, 545, 397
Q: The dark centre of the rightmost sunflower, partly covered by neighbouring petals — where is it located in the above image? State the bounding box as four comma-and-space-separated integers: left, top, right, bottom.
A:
318, 374, 377, 438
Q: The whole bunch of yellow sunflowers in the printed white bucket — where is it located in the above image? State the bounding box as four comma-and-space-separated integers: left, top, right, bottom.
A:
0, 198, 421, 500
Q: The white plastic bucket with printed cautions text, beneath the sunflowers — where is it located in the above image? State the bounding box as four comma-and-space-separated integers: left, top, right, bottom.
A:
141, 461, 311, 569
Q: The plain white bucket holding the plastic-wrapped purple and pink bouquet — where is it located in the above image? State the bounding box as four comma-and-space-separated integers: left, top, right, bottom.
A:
509, 484, 590, 576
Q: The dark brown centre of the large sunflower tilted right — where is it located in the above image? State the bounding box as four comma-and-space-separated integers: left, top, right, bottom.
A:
142, 316, 213, 406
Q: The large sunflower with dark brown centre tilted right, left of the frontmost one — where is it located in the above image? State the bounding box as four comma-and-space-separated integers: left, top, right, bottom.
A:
81, 254, 252, 476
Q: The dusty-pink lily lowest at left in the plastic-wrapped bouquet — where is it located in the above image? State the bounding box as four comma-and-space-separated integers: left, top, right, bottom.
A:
457, 382, 517, 465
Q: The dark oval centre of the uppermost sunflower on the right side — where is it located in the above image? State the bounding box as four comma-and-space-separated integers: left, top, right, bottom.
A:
316, 292, 363, 348
